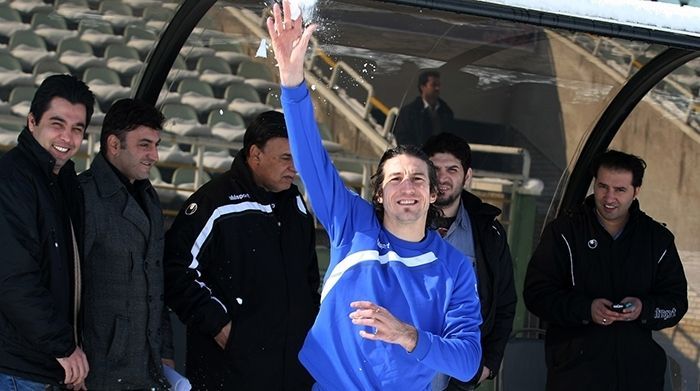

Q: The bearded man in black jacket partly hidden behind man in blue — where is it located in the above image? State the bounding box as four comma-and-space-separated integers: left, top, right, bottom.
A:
423, 133, 517, 391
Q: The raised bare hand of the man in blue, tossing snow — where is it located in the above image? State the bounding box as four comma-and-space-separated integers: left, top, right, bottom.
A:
267, 0, 316, 87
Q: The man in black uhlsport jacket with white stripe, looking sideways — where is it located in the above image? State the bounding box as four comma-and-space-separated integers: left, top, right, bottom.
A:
164, 111, 320, 391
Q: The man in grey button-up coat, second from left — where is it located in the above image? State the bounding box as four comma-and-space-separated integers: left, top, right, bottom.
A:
80, 99, 173, 390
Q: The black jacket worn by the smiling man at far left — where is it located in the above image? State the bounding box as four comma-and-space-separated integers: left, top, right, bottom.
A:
0, 129, 83, 384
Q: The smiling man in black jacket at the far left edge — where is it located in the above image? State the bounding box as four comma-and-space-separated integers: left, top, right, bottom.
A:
0, 75, 94, 390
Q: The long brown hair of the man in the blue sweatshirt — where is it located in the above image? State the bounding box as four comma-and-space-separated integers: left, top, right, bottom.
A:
372, 145, 442, 228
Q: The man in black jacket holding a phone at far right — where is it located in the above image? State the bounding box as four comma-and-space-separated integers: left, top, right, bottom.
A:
524, 151, 688, 391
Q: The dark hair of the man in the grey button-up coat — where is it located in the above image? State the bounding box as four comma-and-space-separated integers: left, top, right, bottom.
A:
100, 98, 165, 156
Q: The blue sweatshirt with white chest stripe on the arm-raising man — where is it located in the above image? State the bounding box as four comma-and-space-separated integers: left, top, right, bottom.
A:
282, 86, 481, 390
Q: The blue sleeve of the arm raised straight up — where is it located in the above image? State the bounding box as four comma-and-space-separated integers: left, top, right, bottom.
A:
281, 83, 364, 245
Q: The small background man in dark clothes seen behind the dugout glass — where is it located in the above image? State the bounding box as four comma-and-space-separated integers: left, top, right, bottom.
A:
394, 71, 454, 145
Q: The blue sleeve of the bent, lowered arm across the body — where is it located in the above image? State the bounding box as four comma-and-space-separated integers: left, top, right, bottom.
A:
410, 260, 481, 381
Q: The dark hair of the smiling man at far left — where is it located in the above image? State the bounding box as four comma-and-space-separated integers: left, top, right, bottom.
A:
29, 74, 95, 129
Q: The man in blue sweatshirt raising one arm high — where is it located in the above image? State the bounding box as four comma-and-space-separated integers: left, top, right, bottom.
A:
268, 1, 481, 390
